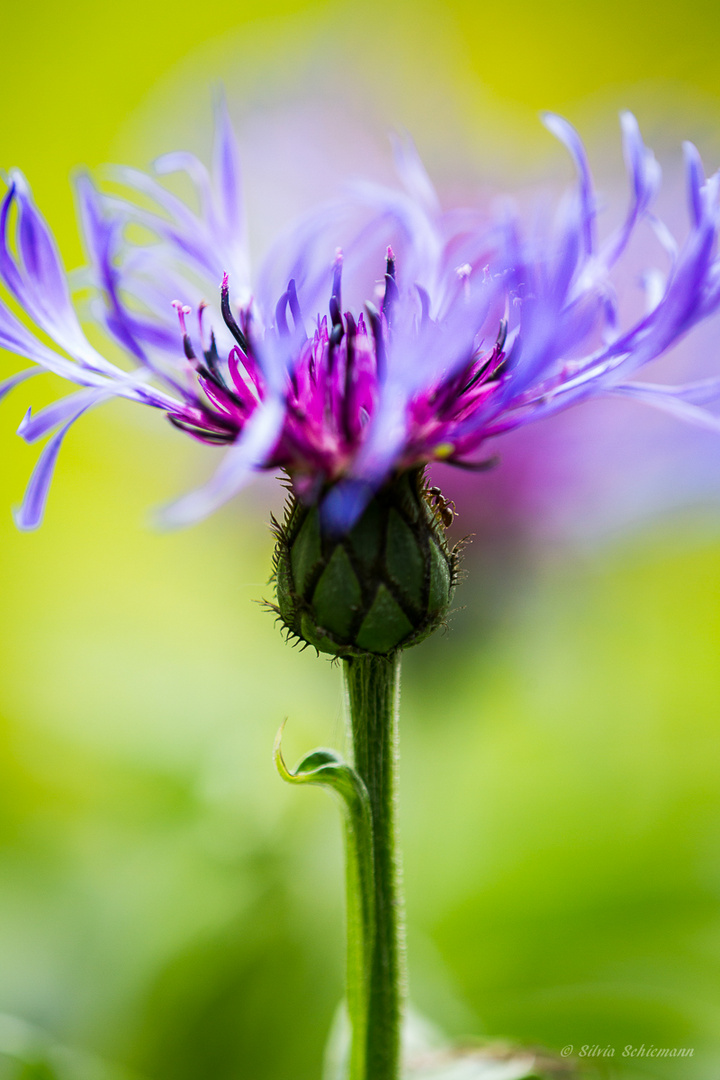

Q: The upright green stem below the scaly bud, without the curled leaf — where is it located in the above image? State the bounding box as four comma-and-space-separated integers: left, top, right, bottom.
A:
343, 653, 405, 1080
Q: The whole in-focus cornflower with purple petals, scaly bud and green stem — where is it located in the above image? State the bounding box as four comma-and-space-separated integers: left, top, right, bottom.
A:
0, 109, 720, 1080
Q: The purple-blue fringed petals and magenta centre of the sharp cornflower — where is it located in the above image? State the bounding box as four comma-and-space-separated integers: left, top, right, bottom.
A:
0, 109, 720, 529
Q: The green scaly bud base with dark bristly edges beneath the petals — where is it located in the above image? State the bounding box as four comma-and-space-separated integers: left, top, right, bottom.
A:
272, 470, 458, 657
